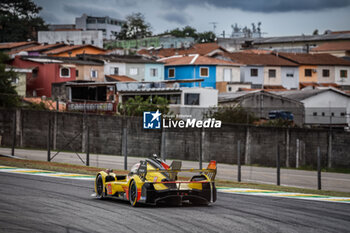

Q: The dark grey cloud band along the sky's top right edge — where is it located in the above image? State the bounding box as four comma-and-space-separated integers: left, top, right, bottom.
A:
162, 0, 350, 13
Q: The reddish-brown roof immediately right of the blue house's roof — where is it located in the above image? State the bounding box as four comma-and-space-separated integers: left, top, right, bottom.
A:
221, 52, 297, 66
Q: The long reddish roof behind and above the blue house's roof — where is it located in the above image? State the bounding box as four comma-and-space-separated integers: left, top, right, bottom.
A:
138, 43, 223, 57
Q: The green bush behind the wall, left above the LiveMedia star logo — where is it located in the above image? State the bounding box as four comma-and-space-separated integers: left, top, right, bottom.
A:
118, 96, 169, 116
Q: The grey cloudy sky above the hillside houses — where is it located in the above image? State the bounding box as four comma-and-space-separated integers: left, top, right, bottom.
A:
34, 0, 350, 36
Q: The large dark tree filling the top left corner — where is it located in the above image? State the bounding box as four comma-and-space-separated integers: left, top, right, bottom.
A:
0, 0, 47, 42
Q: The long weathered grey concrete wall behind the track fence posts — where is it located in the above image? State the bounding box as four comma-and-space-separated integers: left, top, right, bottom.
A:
0, 110, 350, 168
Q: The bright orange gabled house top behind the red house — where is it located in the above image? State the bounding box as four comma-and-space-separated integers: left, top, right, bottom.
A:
44, 45, 106, 57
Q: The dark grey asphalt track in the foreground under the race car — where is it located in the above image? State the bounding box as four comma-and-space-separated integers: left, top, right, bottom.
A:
0, 173, 350, 232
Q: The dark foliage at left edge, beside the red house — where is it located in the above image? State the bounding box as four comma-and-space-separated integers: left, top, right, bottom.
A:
0, 53, 20, 108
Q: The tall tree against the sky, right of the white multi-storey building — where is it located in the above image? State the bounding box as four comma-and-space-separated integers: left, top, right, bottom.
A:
118, 13, 152, 40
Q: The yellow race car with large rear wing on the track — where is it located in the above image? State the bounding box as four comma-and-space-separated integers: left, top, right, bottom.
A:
95, 155, 216, 206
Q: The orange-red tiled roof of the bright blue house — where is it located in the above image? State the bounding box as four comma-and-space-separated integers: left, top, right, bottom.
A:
158, 54, 239, 66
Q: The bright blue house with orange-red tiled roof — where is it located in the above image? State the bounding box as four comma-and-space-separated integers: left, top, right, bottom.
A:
158, 54, 236, 89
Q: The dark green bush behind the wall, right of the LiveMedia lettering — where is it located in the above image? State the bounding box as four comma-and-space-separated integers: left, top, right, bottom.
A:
205, 106, 257, 124
